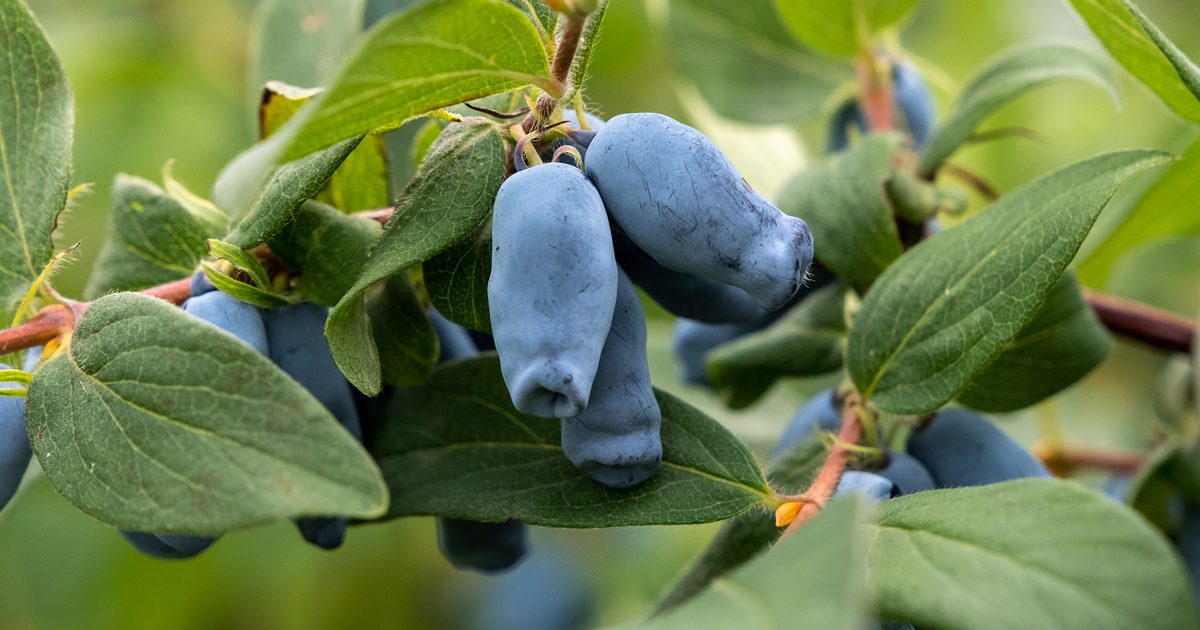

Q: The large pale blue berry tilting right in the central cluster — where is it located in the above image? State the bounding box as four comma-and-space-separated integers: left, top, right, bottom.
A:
584, 114, 812, 311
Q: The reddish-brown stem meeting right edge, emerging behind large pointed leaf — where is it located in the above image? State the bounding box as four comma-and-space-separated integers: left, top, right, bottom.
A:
1084, 289, 1196, 354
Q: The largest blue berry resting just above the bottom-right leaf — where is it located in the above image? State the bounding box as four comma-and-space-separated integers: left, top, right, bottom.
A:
908, 409, 1050, 487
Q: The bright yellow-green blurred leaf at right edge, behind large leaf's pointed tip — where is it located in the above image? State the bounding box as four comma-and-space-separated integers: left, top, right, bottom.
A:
1079, 142, 1200, 287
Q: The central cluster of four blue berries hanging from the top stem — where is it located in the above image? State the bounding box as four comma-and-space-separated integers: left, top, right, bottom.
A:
488, 114, 812, 488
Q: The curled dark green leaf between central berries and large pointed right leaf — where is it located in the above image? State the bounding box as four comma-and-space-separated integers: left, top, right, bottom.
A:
708, 284, 846, 409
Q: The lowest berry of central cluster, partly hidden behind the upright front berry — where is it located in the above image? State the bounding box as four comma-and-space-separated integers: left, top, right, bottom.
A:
562, 271, 662, 488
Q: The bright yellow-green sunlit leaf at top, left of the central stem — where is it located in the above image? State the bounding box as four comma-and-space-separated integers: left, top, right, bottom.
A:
281, 0, 549, 160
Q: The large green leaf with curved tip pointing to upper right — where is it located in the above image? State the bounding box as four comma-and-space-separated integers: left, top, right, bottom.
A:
846, 151, 1170, 414
